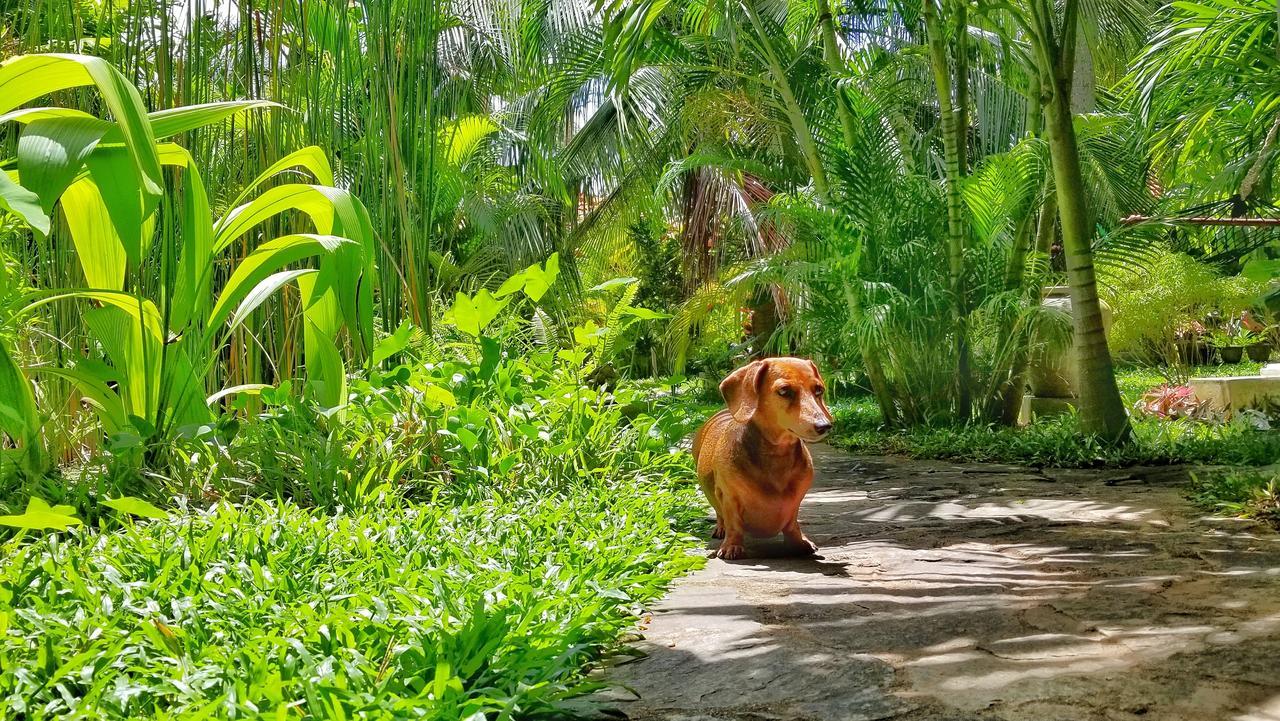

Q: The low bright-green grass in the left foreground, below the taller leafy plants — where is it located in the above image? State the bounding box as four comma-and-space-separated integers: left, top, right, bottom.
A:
0, 478, 698, 720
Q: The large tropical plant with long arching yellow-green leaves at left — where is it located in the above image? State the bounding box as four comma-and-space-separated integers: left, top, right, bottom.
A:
0, 55, 375, 466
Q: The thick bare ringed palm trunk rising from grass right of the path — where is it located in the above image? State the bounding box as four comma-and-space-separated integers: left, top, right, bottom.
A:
1036, 0, 1130, 442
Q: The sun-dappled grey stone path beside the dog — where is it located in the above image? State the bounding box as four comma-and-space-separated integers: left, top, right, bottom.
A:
593, 447, 1280, 721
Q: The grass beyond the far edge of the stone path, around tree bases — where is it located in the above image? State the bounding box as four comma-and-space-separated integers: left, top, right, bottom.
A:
832, 364, 1280, 467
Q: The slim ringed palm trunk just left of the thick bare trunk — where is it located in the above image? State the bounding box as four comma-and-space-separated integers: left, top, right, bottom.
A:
924, 0, 972, 420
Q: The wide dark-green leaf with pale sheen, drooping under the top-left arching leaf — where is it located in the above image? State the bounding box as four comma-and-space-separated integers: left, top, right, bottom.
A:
18, 117, 111, 213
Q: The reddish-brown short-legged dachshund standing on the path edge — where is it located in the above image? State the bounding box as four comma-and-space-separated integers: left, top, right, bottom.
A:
694, 357, 832, 558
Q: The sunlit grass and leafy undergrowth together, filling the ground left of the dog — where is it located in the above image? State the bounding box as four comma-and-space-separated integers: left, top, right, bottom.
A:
0, 283, 701, 720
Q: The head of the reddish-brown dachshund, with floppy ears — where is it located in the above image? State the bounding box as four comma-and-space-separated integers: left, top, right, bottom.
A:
721, 357, 832, 443
